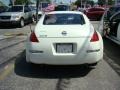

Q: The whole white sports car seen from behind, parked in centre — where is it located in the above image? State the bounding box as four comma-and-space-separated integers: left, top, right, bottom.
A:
26, 11, 103, 65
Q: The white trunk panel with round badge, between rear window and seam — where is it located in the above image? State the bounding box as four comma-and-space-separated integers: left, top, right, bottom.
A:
35, 25, 91, 38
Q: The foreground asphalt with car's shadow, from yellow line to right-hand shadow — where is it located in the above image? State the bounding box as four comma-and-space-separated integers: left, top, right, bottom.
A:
0, 52, 120, 90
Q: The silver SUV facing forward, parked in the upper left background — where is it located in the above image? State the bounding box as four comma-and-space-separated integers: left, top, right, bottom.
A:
0, 5, 32, 27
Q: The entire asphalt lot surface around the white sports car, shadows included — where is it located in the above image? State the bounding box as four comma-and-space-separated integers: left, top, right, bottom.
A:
0, 22, 120, 90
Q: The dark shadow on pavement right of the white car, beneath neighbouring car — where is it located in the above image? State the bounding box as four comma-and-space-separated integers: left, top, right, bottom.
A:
103, 38, 120, 75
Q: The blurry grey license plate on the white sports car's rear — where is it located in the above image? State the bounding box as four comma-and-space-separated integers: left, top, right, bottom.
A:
56, 43, 73, 53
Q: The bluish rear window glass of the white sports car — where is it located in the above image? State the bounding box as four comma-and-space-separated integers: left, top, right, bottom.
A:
43, 14, 85, 25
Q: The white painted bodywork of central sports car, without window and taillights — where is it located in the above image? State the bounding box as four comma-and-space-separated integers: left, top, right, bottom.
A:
26, 11, 103, 65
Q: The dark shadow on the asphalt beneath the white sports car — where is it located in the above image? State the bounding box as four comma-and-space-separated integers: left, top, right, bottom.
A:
14, 51, 94, 78
